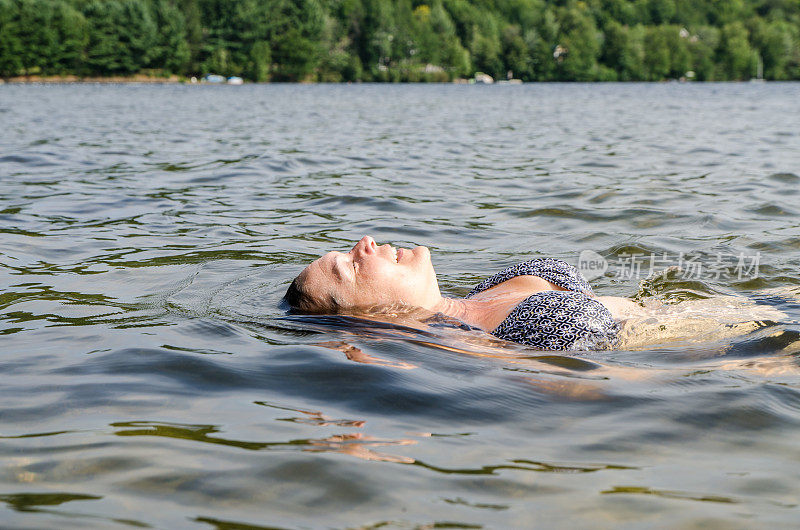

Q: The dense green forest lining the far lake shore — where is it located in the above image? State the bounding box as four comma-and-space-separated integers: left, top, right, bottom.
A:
0, 0, 800, 82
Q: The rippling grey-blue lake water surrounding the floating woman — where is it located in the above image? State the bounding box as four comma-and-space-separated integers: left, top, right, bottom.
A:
0, 83, 800, 529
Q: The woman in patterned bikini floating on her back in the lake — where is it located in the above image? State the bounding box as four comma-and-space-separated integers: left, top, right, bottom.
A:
284, 236, 786, 350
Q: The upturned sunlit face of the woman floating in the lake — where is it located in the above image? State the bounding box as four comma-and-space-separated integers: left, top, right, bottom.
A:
301, 236, 441, 309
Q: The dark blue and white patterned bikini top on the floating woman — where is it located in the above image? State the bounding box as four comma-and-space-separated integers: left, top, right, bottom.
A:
467, 258, 619, 350
